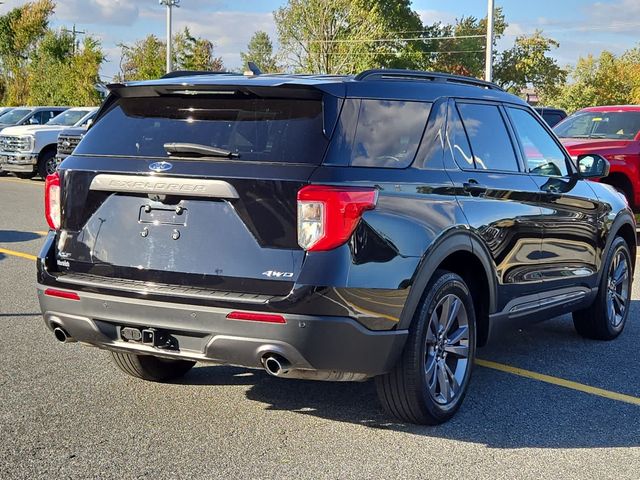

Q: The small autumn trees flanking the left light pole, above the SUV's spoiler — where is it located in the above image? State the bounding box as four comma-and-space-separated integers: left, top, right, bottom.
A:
118, 28, 224, 81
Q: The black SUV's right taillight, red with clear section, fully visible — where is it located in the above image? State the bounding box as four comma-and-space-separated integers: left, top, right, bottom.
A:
298, 185, 377, 252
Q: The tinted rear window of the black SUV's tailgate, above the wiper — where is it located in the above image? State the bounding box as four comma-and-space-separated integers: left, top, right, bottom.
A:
75, 96, 327, 164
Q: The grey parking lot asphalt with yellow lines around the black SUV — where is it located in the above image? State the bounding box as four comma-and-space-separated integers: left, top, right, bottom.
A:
0, 177, 640, 480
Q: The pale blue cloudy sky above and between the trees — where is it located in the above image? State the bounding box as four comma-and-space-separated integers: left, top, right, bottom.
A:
0, 0, 640, 81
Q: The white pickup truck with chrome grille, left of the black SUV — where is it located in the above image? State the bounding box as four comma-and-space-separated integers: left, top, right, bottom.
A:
0, 107, 98, 178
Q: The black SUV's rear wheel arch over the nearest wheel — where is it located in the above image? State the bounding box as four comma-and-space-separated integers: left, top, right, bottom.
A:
398, 229, 497, 345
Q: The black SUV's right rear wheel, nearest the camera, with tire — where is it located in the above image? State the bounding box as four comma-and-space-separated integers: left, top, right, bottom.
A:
376, 270, 476, 425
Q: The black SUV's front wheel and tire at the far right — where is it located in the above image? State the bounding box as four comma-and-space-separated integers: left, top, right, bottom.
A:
573, 237, 633, 340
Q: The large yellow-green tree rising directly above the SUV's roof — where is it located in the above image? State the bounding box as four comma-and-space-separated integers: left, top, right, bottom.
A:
274, 0, 423, 74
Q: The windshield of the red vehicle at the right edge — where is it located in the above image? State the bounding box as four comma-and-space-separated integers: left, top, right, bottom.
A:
554, 112, 640, 140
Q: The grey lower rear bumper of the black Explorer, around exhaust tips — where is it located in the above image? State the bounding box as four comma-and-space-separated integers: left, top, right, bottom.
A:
38, 285, 407, 376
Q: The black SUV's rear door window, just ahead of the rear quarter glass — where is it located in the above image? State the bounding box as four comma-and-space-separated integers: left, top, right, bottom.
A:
458, 103, 519, 172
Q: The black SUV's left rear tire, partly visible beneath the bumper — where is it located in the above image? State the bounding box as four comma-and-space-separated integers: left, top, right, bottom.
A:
111, 352, 196, 382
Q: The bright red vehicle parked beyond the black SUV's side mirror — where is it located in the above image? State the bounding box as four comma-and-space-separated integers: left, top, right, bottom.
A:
553, 105, 640, 211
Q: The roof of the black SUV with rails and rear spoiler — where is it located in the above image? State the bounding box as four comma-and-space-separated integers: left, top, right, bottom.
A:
109, 70, 526, 105
